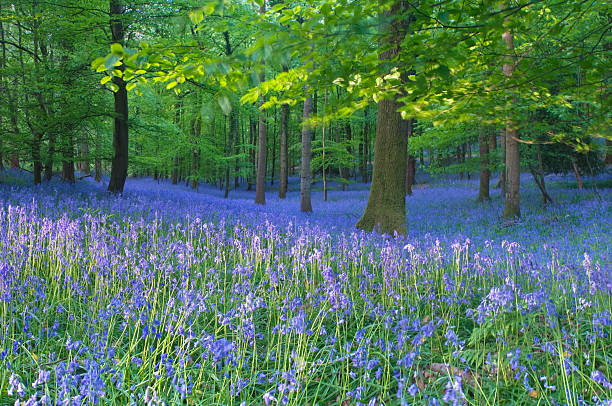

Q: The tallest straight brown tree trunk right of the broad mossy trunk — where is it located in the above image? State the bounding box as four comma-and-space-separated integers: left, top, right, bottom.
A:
503, 25, 521, 219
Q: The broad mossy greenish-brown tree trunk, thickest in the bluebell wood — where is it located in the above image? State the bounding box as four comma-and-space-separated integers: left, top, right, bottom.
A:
357, 0, 408, 234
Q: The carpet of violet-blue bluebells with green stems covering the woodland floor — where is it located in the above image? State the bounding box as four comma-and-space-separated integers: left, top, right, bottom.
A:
0, 169, 612, 406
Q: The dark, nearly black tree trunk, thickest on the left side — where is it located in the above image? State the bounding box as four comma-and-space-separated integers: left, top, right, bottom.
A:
108, 0, 128, 193
